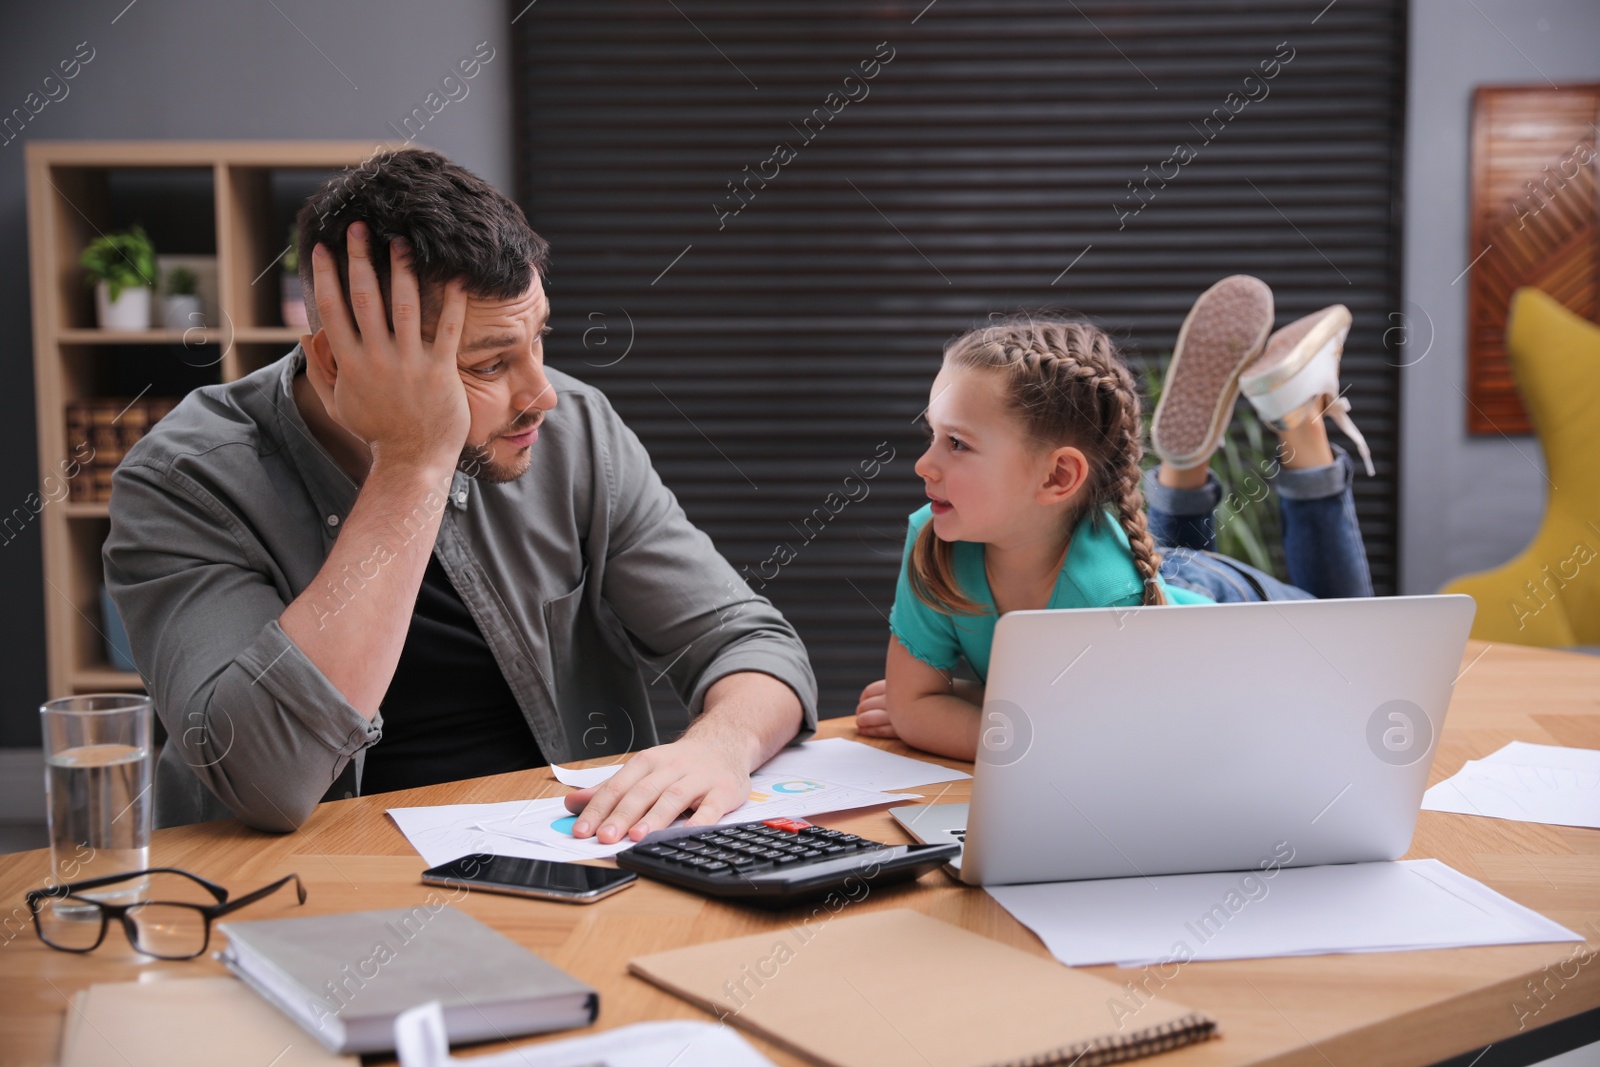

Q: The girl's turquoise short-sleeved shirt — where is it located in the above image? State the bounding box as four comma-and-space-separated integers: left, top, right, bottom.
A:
890, 504, 1211, 681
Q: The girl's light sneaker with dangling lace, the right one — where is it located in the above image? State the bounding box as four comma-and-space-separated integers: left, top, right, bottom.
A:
1238, 304, 1378, 477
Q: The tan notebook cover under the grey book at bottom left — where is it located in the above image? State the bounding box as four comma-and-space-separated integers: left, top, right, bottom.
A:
61, 976, 360, 1067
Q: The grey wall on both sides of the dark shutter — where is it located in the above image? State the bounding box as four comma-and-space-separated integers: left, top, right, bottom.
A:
0, 0, 1580, 745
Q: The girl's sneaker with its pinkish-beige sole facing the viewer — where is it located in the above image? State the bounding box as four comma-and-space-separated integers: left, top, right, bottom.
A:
1150, 274, 1272, 470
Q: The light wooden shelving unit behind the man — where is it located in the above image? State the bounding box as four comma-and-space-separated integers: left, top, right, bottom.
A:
26, 141, 389, 696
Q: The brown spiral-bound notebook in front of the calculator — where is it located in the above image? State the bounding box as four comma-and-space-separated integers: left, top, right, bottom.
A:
629, 909, 1216, 1067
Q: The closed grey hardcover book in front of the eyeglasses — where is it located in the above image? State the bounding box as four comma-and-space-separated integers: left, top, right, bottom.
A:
219, 905, 600, 1053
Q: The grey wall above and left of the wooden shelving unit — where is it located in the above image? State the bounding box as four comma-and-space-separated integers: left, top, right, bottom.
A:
0, 0, 522, 745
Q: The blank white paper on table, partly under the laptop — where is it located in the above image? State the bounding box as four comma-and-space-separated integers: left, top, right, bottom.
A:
987, 859, 1582, 966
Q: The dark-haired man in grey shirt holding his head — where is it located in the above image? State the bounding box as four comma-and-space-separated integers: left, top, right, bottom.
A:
104, 149, 816, 843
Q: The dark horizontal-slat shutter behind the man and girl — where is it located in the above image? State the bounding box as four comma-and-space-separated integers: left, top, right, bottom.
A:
512, 0, 1405, 726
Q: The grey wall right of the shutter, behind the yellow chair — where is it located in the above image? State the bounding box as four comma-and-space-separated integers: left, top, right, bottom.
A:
1401, 0, 1600, 593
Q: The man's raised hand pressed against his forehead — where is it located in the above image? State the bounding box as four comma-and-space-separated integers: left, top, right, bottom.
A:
302, 222, 470, 469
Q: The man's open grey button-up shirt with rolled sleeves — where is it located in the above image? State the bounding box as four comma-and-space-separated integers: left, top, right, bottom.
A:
104, 347, 816, 830
